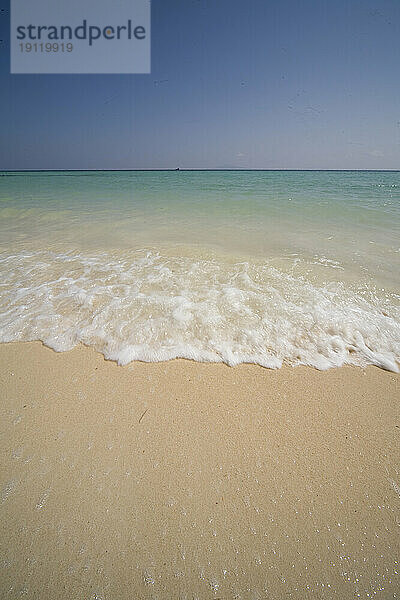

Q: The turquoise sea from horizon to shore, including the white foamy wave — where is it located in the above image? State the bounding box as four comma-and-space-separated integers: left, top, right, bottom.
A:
0, 171, 400, 371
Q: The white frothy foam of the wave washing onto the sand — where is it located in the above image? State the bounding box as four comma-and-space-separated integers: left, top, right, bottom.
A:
0, 251, 400, 372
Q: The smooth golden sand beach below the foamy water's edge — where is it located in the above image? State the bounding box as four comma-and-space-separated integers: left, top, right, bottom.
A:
0, 342, 400, 600
